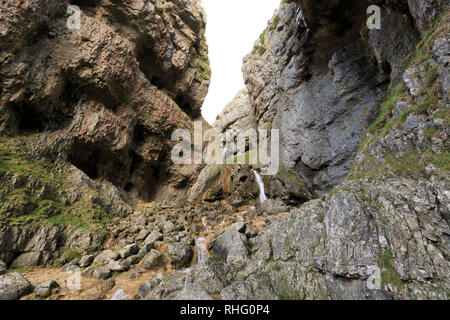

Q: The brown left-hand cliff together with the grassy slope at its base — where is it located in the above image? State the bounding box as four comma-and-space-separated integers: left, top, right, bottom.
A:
0, 0, 210, 267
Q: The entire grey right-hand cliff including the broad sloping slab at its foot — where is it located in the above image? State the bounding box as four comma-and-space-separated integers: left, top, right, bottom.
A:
234, 1, 450, 299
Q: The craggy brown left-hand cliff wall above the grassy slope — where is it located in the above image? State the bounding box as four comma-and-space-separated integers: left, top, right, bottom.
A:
0, 0, 210, 205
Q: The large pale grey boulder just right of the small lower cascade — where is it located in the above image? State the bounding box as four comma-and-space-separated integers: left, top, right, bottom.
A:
211, 230, 249, 268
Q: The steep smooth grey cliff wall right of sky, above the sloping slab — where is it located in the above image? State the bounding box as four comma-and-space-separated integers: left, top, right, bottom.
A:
243, 1, 428, 194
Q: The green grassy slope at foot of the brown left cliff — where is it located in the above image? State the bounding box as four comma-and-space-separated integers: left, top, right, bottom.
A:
0, 136, 109, 229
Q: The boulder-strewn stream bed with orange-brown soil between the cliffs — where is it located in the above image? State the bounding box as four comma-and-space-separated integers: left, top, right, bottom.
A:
0, 203, 288, 300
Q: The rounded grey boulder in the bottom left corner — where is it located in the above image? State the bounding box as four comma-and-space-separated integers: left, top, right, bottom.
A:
0, 272, 34, 300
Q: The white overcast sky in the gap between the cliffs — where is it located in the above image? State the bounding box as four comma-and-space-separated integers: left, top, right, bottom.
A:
202, 0, 281, 123
